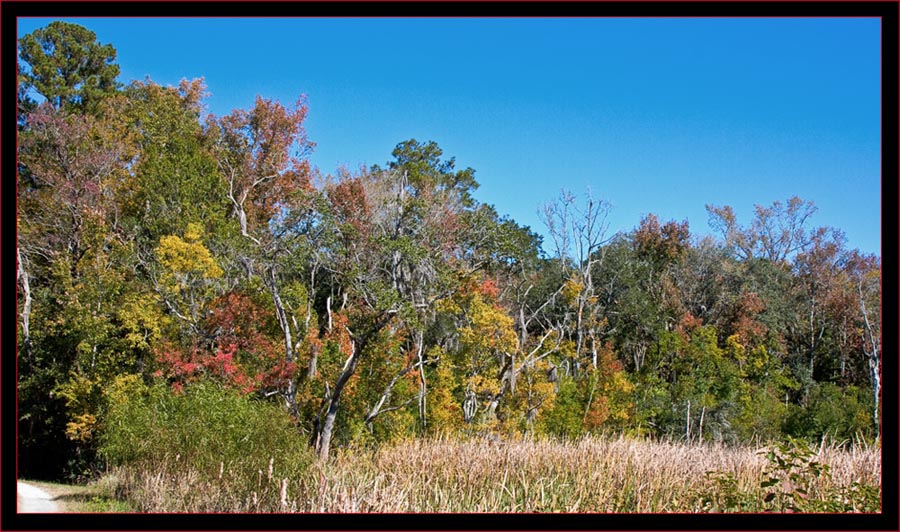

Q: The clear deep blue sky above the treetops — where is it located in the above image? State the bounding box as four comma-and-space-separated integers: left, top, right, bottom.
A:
19, 18, 880, 253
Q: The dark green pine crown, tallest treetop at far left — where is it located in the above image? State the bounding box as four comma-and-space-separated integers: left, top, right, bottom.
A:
19, 21, 119, 113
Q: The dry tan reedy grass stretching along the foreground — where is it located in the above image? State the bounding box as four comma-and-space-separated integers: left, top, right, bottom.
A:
98, 437, 881, 513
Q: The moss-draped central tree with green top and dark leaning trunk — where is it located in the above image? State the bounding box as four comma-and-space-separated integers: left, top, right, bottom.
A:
316, 140, 502, 458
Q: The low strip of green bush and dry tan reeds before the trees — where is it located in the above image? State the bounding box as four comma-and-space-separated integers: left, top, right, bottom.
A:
101, 383, 881, 513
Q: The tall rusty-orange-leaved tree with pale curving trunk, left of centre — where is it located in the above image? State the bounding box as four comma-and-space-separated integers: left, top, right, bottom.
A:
208, 97, 316, 413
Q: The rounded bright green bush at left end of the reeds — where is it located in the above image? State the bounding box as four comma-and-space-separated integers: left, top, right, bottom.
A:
100, 377, 312, 475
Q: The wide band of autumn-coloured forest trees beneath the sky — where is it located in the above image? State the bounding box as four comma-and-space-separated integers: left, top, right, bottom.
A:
16, 22, 882, 512
